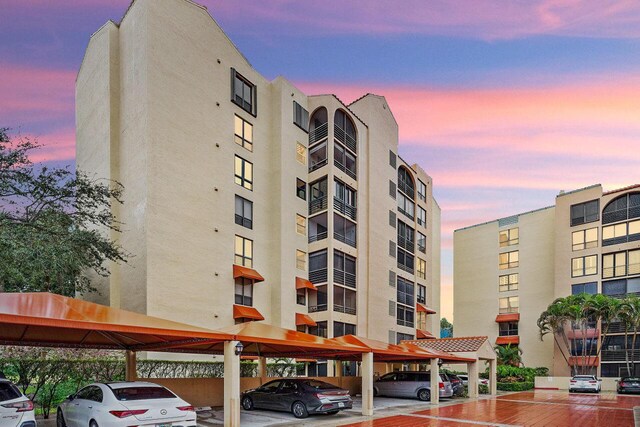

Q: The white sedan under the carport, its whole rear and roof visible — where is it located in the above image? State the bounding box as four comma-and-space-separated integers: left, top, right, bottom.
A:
57, 382, 196, 427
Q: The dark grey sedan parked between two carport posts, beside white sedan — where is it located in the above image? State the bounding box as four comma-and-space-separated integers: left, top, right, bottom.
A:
240, 378, 353, 418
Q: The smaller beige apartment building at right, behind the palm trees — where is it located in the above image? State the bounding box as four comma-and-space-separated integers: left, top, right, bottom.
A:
454, 185, 640, 377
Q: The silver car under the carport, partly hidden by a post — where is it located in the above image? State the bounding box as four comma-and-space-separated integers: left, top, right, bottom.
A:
373, 371, 453, 401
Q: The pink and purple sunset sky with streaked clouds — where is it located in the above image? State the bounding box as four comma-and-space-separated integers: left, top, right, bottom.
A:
0, 0, 640, 318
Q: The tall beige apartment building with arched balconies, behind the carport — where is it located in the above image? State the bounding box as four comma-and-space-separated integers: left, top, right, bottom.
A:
76, 0, 440, 372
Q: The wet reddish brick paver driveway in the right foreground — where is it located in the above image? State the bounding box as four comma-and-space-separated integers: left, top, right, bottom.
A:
338, 390, 640, 427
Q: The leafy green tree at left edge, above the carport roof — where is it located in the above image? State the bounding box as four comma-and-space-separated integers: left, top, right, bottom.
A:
0, 128, 128, 296
